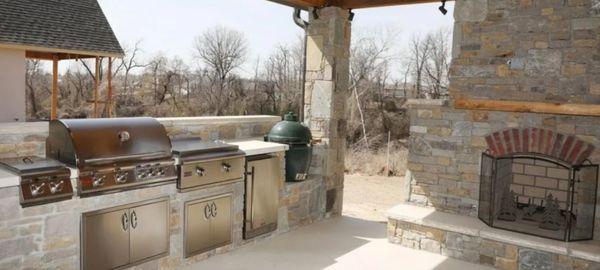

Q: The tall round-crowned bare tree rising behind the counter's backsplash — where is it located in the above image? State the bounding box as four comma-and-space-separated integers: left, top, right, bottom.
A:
194, 26, 248, 115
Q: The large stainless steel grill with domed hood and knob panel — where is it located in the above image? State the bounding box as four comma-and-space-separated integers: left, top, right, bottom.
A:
46, 118, 177, 196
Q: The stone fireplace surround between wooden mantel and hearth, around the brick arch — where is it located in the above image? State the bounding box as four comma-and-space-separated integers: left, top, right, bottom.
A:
408, 100, 600, 231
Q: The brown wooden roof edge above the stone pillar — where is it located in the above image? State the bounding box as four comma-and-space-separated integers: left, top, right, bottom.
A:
267, 0, 451, 9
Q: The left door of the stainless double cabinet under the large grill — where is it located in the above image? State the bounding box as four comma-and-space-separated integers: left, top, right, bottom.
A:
82, 209, 129, 270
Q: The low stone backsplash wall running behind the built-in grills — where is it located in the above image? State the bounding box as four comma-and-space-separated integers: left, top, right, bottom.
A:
0, 116, 281, 158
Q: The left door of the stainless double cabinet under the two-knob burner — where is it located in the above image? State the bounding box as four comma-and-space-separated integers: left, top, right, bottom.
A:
183, 201, 212, 258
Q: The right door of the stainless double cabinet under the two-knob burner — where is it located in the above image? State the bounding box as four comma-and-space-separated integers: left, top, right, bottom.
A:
210, 196, 231, 247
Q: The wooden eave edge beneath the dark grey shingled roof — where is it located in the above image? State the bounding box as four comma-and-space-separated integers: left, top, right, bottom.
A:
0, 43, 123, 60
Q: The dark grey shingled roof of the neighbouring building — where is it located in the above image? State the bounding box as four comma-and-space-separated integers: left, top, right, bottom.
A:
0, 0, 123, 56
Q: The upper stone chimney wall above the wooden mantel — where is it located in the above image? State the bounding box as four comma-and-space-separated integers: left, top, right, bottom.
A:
450, 0, 600, 104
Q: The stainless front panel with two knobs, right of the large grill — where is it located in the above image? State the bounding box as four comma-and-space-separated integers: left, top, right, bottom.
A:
179, 157, 244, 189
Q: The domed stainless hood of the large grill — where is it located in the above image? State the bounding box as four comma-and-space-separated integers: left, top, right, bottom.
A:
46, 117, 171, 168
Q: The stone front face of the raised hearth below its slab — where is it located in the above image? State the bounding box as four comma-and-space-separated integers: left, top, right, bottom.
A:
388, 219, 600, 270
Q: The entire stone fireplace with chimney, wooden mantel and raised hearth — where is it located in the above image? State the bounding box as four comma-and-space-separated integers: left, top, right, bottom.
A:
388, 0, 600, 269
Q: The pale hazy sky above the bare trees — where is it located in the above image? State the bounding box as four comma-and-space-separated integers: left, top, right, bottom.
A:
86, 0, 454, 76
